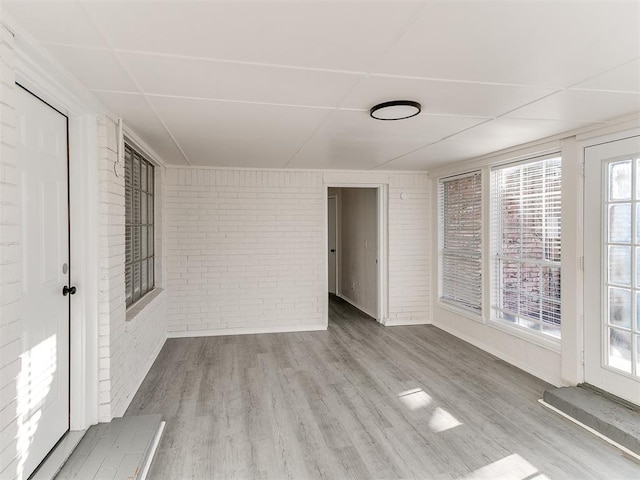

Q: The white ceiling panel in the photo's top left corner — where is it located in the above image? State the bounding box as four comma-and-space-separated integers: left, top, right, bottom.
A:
2, 0, 107, 48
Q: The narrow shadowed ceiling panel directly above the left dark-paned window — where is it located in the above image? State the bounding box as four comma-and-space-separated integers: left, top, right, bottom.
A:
95, 92, 187, 165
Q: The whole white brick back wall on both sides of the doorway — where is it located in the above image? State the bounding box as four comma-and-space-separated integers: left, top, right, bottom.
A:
163, 168, 430, 336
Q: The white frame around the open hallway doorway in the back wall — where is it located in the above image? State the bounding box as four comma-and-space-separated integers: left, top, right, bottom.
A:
324, 182, 389, 325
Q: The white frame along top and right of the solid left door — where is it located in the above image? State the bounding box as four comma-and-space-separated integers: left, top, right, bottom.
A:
9, 33, 100, 430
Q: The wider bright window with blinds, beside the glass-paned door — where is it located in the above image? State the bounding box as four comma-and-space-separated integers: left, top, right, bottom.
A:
492, 156, 562, 338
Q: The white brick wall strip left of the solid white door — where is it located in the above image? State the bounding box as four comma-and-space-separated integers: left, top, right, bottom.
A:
0, 24, 22, 480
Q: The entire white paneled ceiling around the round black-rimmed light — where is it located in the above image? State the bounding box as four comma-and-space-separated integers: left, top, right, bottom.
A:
3, 0, 640, 170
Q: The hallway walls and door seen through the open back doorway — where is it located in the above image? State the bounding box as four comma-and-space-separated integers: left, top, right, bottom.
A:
327, 185, 386, 323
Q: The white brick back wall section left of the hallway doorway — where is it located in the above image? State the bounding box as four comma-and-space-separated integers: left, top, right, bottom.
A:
164, 169, 326, 336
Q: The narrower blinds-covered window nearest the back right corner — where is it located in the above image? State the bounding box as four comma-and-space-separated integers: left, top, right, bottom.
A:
439, 172, 482, 314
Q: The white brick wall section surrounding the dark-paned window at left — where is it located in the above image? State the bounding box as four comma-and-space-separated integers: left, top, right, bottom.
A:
98, 116, 167, 422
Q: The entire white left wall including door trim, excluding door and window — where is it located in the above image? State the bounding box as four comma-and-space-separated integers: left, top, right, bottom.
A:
0, 20, 171, 480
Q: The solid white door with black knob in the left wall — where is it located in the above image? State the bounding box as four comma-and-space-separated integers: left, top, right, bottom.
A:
16, 87, 70, 478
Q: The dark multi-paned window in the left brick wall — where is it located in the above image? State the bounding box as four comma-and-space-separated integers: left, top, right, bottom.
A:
124, 145, 154, 306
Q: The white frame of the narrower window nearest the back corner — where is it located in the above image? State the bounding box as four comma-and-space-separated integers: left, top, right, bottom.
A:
437, 169, 485, 322
